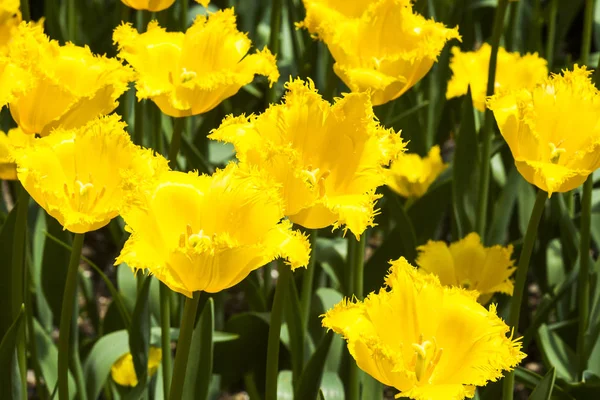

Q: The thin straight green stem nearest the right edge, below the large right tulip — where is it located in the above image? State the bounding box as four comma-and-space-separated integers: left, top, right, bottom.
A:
577, 175, 594, 380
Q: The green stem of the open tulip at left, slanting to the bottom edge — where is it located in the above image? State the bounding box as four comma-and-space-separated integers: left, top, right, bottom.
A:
58, 233, 84, 399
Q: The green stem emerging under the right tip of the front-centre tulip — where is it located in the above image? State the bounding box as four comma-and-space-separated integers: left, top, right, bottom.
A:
265, 262, 292, 400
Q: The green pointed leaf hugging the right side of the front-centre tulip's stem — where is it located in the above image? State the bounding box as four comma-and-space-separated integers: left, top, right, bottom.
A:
183, 297, 215, 400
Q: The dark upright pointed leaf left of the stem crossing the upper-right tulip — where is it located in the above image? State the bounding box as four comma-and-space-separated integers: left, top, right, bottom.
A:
452, 88, 479, 239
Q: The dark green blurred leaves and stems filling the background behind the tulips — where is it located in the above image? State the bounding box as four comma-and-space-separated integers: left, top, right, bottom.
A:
0, 0, 600, 400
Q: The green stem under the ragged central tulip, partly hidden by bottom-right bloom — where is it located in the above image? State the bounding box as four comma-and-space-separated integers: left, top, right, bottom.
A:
347, 233, 366, 400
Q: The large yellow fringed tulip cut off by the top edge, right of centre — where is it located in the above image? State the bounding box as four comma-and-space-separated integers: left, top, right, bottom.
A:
299, 0, 460, 105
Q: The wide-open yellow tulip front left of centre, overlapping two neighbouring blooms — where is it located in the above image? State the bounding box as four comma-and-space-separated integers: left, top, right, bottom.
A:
116, 164, 310, 297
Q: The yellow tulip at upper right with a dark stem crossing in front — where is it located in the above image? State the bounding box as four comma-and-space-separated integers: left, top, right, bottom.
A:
446, 43, 548, 111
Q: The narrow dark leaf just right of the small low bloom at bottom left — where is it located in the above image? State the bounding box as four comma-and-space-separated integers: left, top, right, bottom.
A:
129, 275, 152, 387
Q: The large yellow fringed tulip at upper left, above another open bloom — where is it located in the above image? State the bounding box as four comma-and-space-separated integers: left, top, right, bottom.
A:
0, 22, 134, 136
